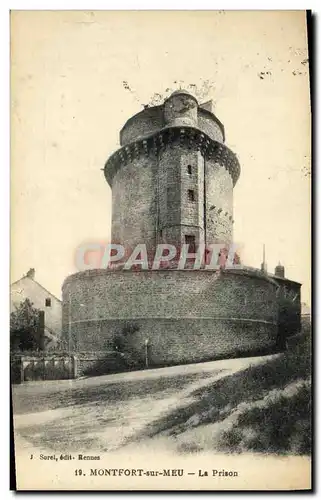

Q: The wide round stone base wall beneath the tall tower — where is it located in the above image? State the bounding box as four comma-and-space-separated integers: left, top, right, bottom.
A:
63, 269, 278, 369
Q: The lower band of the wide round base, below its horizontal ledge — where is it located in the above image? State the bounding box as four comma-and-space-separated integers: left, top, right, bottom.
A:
67, 318, 277, 367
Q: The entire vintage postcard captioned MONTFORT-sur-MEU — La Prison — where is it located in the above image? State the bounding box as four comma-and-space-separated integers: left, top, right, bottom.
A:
10, 10, 312, 491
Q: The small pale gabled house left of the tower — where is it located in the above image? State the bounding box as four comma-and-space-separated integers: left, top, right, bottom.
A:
10, 269, 62, 345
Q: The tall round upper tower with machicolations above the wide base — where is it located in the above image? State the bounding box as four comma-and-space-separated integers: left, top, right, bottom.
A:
105, 90, 240, 258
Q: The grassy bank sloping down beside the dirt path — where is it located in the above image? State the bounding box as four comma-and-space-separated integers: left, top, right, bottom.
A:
140, 326, 311, 455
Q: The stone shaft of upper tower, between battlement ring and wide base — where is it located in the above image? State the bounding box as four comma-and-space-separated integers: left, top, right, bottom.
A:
112, 143, 233, 249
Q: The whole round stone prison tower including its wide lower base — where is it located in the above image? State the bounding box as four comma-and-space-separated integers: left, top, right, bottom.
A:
62, 90, 300, 374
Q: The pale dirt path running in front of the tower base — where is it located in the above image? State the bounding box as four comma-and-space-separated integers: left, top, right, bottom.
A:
13, 356, 274, 452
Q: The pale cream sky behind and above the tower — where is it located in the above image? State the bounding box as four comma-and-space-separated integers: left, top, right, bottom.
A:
11, 11, 311, 302
